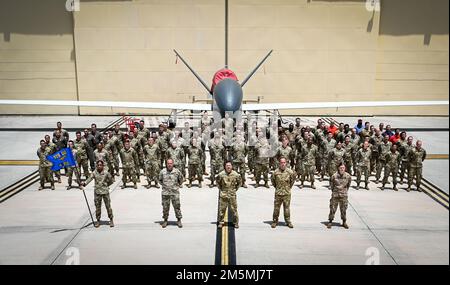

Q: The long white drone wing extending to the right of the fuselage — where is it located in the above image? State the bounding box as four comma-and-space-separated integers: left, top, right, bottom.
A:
242, 101, 448, 111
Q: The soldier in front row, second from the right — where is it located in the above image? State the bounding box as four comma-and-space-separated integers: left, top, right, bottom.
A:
271, 157, 296, 229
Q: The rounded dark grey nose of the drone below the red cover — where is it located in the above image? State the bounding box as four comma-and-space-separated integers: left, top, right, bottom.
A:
214, 78, 242, 113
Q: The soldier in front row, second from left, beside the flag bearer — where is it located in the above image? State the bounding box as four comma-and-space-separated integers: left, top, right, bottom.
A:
159, 158, 183, 228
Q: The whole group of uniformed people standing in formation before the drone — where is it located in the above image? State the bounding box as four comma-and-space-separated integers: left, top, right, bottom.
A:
37, 112, 426, 228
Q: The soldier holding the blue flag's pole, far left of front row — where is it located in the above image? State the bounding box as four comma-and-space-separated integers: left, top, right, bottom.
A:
83, 160, 114, 228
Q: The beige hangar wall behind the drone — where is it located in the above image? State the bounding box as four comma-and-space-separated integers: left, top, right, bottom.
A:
0, 0, 449, 115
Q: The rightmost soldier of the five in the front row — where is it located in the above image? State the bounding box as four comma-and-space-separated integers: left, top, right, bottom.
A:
327, 163, 354, 229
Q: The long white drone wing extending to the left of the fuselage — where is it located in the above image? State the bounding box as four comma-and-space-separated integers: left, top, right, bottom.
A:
0, 100, 211, 111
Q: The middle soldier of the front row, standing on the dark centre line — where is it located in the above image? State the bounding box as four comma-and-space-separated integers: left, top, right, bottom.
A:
217, 161, 242, 229
